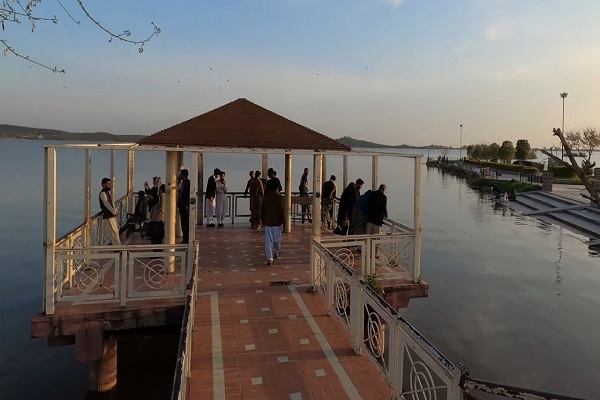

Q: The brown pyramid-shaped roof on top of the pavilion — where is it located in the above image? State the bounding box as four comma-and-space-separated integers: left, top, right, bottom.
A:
138, 99, 350, 151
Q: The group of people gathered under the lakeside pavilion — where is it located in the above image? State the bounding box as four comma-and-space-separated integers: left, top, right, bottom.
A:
99, 168, 387, 265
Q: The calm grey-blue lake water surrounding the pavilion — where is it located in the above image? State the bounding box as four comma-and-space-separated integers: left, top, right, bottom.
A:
0, 141, 600, 400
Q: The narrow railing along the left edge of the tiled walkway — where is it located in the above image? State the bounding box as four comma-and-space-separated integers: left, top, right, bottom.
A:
171, 241, 199, 400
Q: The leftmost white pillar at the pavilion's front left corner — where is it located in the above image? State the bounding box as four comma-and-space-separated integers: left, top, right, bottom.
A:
43, 147, 56, 315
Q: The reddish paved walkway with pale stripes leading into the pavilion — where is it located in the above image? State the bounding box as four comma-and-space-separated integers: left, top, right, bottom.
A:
189, 224, 391, 400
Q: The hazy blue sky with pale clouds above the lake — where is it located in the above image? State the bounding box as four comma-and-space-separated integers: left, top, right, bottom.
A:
0, 0, 600, 146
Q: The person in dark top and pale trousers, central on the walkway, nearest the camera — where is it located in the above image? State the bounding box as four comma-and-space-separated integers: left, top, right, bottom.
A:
261, 179, 285, 265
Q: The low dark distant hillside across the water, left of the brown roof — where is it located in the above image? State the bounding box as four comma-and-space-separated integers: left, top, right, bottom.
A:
0, 125, 144, 142
